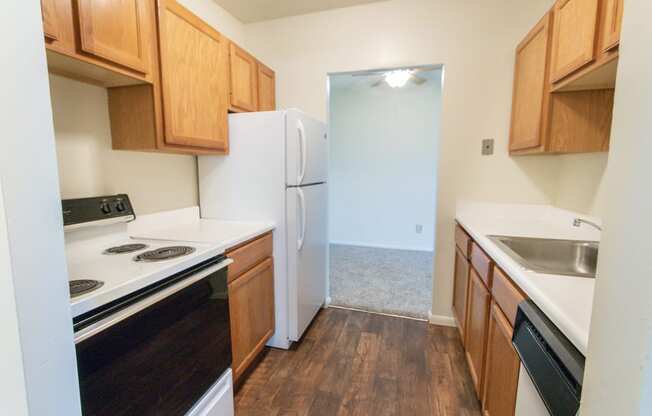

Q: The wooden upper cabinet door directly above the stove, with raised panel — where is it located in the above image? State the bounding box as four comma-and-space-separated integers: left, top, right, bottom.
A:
76, 0, 150, 73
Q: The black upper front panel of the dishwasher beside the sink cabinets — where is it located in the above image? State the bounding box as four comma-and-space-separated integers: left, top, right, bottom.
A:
512, 300, 584, 416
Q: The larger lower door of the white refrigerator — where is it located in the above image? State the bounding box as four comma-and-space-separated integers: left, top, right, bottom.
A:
286, 184, 328, 341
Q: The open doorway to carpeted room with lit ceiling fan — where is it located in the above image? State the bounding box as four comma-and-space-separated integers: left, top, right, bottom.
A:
329, 66, 443, 319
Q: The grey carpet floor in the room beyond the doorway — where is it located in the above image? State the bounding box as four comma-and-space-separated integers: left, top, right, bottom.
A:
330, 244, 433, 319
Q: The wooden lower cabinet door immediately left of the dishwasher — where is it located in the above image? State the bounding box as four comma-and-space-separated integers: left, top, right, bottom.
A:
482, 303, 520, 416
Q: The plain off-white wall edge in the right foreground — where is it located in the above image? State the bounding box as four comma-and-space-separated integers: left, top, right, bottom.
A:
581, 1, 652, 416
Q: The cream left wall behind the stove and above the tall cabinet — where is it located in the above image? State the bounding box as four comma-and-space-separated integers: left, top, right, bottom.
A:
50, 0, 246, 214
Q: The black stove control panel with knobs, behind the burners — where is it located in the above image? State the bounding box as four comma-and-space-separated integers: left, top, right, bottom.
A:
61, 194, 136, 229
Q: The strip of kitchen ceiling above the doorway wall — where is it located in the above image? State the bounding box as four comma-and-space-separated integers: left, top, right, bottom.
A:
214, 0, 386, 23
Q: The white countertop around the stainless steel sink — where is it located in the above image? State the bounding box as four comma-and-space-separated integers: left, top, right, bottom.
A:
455, 203, 600, 355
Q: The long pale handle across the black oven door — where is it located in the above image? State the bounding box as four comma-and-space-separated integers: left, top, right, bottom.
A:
74, 259, 233, 344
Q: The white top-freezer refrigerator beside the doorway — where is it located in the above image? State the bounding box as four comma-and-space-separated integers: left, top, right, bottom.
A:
199, 110, 328, 348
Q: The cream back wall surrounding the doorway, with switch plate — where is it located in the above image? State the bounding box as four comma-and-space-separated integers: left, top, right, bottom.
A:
247, 0, 557, 317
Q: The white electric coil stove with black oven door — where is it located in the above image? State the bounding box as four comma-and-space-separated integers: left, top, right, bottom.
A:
62, 195, 233, 416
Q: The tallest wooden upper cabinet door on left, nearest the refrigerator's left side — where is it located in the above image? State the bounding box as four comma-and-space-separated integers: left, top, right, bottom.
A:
159, 0, 229, 152
